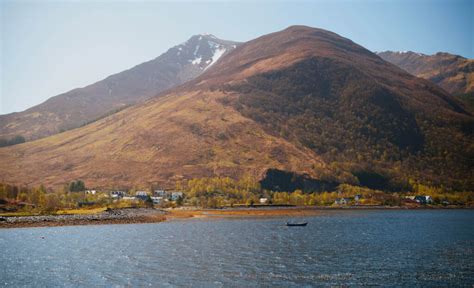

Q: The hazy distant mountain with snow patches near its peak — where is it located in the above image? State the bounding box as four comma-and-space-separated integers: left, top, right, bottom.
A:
0, 34, 238, 140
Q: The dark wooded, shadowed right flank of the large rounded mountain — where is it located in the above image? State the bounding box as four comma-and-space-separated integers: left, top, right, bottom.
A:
226, 57, 474, 191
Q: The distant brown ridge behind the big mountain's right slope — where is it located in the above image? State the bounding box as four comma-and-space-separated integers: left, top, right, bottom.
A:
377, 51, 474, 95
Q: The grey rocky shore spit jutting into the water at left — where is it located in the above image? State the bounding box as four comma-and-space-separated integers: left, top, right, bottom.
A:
0, 208, 166, 228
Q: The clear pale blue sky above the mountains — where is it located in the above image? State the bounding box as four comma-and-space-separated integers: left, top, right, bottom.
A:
0, 0, 474, 114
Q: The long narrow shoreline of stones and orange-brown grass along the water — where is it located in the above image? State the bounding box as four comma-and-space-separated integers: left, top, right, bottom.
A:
0, 206, 473, 229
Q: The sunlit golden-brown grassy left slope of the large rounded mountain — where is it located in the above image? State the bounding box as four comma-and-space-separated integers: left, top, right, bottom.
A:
0, 91, 323, 187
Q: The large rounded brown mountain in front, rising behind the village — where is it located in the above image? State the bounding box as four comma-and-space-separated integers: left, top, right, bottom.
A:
0, 26, 474, 190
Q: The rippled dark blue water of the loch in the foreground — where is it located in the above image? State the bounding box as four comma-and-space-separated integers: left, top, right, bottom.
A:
0, 210, 474, 287
